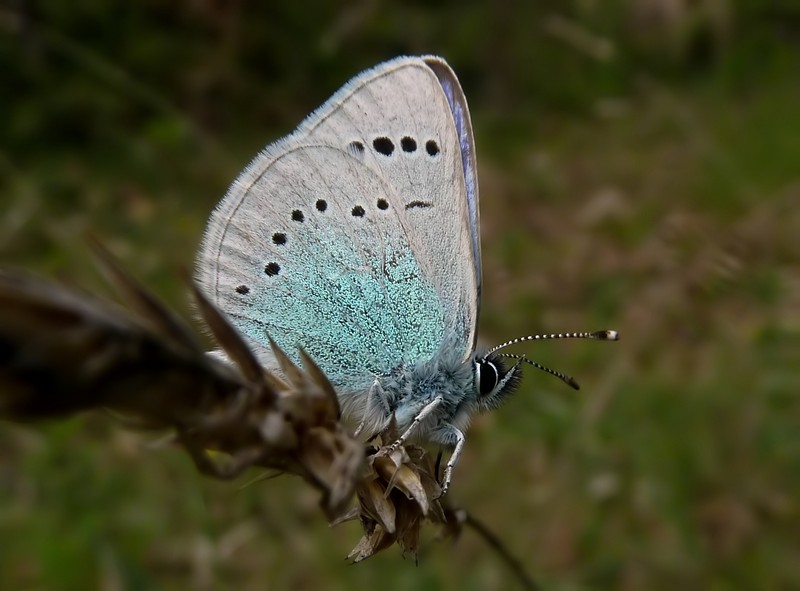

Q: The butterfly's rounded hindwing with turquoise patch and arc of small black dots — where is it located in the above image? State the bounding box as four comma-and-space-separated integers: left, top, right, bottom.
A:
198, 143, 446, 396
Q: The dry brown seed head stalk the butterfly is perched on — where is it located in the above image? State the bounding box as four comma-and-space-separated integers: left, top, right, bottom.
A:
0, 247, 459, 562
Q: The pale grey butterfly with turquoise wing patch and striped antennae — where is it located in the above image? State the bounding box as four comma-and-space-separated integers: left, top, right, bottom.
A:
197, 56, 616, 492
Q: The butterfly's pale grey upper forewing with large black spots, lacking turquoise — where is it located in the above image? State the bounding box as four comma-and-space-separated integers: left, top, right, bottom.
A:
296, 57, 481, 359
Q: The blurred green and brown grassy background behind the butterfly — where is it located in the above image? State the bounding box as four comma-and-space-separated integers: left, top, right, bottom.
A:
0, 0, 800, 591
